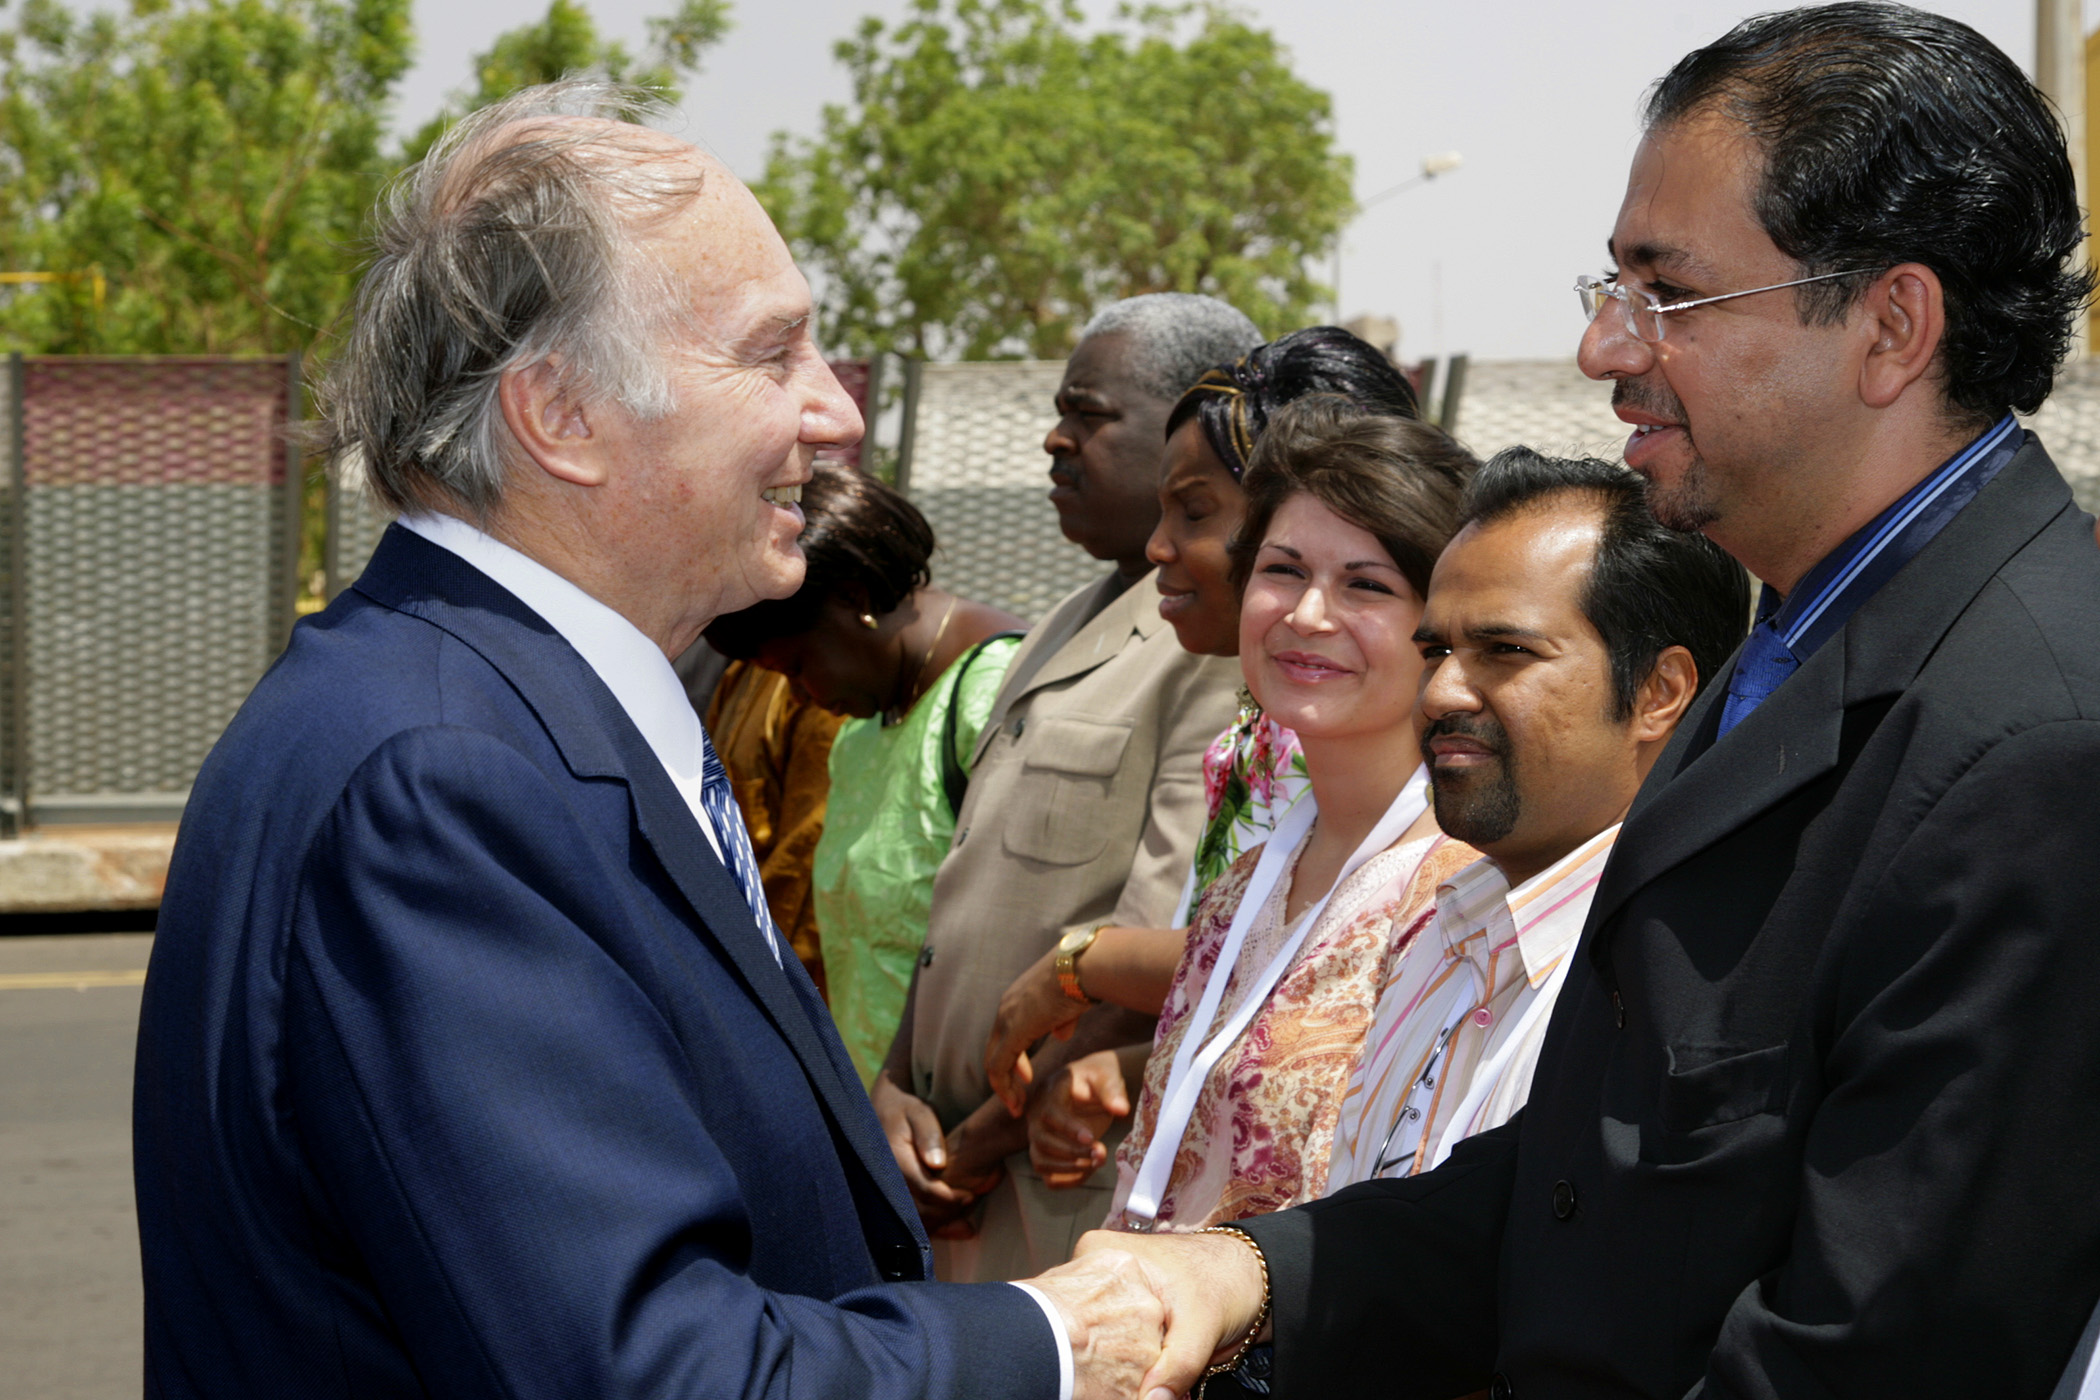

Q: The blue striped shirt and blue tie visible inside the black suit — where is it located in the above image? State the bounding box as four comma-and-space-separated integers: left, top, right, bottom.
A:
1720, 413, 2027, 735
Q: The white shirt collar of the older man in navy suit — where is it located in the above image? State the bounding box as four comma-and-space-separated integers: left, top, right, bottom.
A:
401, 512, 712, 797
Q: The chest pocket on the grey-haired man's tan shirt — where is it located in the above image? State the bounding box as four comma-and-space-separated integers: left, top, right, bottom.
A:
1002, 716, 1136, 865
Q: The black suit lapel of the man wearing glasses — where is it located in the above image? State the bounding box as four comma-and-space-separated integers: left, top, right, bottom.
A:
1590, 439, 2071, 951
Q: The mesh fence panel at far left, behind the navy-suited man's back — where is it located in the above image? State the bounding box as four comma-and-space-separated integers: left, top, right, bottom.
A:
0, 355, 298, 831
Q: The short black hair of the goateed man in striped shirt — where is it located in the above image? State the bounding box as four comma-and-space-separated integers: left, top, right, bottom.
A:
1464, 447, 1749, 720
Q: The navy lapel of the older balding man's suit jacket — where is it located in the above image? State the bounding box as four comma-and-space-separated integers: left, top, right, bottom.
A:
355, 525, 918, 1228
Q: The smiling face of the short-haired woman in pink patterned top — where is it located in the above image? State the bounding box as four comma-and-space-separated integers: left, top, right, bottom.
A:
1239, 493, 1422, 751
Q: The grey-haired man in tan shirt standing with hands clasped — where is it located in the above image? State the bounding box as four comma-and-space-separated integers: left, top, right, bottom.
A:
874, 294, 1260, 1280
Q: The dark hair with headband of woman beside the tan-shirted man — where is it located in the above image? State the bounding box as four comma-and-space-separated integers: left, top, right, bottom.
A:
1168, 325, 1422, 479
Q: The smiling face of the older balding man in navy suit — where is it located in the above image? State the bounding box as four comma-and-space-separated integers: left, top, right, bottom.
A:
601, 153, 861, 630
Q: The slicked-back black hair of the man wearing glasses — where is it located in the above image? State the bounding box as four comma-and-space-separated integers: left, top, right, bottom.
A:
1642, 4, 2094, 422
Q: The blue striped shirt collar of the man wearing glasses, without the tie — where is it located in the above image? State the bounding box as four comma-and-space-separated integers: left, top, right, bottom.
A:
1758, 413, 2027, 659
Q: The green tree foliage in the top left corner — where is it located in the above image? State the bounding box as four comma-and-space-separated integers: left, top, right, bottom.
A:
0, 0, 412, 355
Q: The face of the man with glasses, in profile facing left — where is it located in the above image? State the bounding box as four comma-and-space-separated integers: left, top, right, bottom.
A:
1579, 113, 1859, 558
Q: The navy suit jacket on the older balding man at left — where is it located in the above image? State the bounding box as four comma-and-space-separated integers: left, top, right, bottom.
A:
134, 527, 1058, 1400
